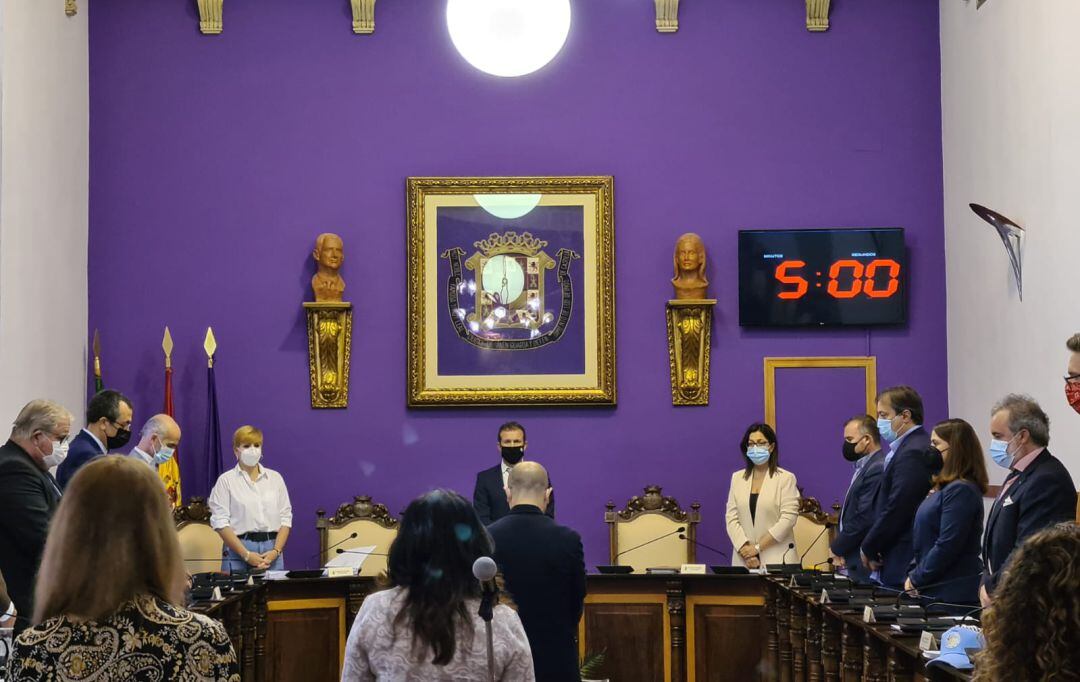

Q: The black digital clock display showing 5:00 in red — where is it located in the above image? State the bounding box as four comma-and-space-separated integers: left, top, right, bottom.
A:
739, 228, 907, 326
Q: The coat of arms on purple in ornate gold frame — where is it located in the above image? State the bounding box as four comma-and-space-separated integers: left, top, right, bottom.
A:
407, 176, 616, 406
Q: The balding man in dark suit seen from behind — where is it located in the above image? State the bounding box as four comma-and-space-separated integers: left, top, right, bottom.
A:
488, 462, 585, 682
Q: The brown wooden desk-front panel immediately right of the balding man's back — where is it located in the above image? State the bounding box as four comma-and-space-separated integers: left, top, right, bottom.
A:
579, 594, 671, 682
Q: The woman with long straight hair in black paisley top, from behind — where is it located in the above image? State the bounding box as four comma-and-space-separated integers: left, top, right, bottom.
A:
10, 455, 240, 682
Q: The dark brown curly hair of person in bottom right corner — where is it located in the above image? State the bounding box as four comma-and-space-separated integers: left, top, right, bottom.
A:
974, 523, 1080, 682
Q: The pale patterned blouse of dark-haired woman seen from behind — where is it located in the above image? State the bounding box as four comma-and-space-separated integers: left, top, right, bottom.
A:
341, 587, 536, 682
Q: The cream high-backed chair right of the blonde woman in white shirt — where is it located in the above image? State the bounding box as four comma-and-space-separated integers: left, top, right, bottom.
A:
315, 495, 397, 575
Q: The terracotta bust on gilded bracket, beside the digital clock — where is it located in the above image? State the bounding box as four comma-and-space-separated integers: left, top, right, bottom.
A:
667, 232, 716, 405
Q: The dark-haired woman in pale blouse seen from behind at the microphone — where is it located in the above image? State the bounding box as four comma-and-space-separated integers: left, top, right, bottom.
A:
341, 490, 536, 682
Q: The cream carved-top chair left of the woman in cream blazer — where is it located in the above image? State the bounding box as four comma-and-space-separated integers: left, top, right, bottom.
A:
604, 485, 701, 573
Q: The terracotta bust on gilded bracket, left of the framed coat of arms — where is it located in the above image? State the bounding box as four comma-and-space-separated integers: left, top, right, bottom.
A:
303, 232, 352, 407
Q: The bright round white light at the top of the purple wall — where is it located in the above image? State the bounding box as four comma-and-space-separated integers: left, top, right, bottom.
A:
446, 0, 570, 78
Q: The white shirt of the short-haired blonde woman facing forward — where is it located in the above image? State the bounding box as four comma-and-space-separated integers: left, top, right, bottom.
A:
207, 464, 293, 535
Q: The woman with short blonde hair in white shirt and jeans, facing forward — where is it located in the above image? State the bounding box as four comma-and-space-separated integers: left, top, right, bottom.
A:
208, 426, 293, 573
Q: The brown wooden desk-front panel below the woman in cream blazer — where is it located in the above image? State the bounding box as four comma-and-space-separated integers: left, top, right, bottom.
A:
686, 597, 766, 682
